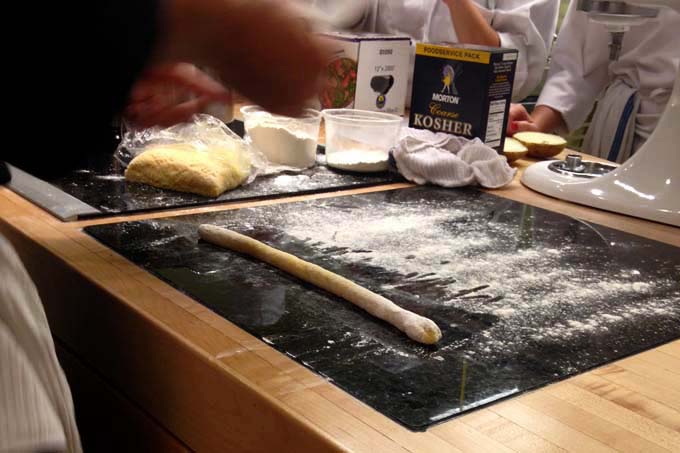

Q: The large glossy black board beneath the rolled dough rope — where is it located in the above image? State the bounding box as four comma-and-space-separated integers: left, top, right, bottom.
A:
86, 187, 680, 430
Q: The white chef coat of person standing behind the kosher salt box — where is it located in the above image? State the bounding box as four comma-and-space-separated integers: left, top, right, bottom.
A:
356, 0, 559, 101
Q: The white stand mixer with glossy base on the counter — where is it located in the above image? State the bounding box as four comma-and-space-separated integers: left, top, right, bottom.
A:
522, 0, 680, 227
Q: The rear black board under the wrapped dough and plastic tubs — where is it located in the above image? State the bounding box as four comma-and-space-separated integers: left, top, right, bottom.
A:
9, 121, 404, 221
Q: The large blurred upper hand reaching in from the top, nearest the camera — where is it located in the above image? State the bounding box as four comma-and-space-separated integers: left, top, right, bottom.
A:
156, 0, 326, 114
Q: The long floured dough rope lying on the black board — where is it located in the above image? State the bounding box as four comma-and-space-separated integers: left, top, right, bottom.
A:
198, 225, 442, 344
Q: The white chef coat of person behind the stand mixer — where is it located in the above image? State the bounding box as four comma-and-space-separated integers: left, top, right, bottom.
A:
537, 1, 680, 153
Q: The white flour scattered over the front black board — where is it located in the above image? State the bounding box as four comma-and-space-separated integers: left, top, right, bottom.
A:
248, 192, 680, 357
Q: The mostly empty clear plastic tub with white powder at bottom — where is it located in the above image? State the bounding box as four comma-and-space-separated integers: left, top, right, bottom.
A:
323, 109, 402, 172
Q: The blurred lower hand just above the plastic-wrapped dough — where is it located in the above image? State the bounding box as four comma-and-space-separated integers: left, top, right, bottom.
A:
124, 63, 231, 128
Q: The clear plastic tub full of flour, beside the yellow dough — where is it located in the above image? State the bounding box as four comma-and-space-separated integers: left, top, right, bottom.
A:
241, 105, 321, 169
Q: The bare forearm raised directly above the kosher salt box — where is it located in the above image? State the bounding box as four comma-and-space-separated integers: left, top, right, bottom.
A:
444, 0, 500, 47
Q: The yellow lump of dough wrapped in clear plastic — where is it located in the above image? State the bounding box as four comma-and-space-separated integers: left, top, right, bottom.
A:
125, 144, 250, 197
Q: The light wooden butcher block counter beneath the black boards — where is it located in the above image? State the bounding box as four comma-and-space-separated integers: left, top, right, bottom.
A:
0, 153, 680, 453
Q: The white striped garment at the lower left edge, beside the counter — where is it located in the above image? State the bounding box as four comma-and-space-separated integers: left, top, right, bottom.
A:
0, 236, 81, 453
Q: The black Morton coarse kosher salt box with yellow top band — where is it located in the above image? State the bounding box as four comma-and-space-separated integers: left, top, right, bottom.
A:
409, 43, 518, 151
